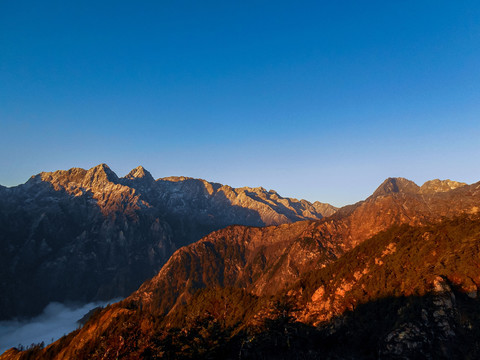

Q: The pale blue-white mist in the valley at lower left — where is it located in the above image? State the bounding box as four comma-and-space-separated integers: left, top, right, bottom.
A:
0, 299, 121, 354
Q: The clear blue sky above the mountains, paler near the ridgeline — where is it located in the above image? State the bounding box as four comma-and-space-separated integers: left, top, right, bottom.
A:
0, 0, 480, 205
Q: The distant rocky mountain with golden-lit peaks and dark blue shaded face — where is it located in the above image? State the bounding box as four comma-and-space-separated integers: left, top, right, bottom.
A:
0, 164, 336, 319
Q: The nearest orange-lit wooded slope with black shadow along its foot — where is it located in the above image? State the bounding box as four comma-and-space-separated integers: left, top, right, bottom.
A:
6, 215, 480, 359
